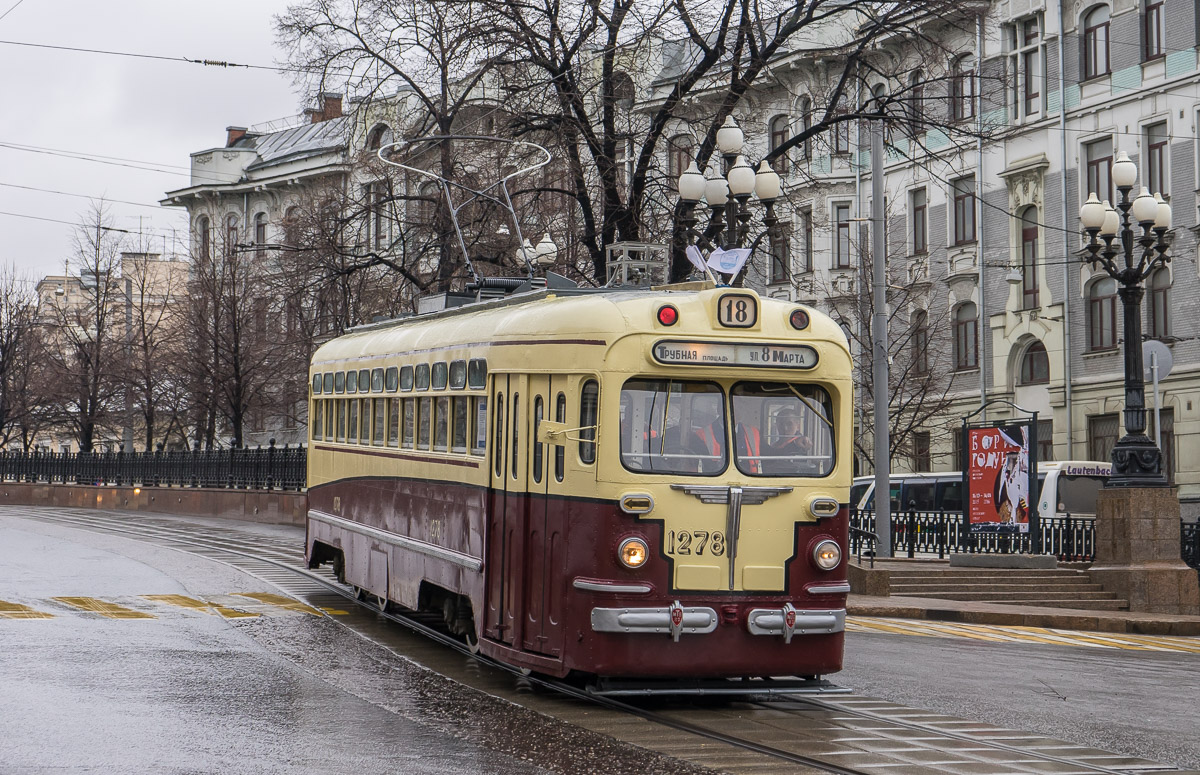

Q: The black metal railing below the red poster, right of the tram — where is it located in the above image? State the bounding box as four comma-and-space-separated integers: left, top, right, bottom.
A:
850, 509, 1096, 561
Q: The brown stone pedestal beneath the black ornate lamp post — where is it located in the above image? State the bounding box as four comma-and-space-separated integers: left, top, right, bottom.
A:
1090, 487, 1200, 615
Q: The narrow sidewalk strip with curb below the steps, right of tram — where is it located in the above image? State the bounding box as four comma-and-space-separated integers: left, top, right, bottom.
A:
846, 594, 1200, 636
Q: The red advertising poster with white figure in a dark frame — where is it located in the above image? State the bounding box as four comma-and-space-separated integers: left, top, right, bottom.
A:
966, 423, 1031, 533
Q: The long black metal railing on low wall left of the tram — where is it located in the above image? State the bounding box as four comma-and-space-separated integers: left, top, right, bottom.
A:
0, 439, 308, 492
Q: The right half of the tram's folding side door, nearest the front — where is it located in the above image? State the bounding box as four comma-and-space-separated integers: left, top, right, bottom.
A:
522, 374, 566, 656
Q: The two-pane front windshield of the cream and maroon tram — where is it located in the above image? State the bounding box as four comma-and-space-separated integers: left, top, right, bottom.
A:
620, 379, 834, 476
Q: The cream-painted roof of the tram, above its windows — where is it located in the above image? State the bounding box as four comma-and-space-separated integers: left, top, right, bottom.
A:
312, 288, 846, 364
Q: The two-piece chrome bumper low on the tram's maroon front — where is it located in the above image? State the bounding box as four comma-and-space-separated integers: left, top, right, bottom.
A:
592, 601, 846, 643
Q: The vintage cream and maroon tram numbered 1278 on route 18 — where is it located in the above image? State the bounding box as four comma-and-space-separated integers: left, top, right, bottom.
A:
306, 286, 852, 679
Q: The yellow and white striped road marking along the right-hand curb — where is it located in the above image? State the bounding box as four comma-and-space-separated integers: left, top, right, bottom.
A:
846, 617, 1200, 654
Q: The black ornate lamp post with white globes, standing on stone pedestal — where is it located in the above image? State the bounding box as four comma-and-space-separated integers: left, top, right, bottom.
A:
1079, 151, 1171, 487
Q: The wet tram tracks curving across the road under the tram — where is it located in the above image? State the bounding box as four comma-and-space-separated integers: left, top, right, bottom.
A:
14, 509, 1185, 775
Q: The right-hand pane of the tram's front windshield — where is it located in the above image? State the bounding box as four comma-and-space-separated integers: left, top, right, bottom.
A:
731, 382, 834, 476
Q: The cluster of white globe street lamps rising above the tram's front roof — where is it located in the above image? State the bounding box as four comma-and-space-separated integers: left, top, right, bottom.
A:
679, 116, 781, 281
